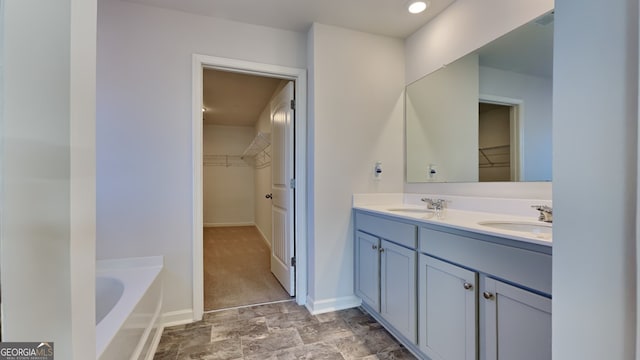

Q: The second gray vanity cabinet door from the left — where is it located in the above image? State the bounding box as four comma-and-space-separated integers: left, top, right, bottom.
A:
380, 240, 417, 343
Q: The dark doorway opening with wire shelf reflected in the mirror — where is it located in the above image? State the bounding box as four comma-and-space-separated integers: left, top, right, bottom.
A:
478, 102, 515, 182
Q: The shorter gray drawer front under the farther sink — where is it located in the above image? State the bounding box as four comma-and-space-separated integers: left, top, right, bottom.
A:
356, 212, 417, 249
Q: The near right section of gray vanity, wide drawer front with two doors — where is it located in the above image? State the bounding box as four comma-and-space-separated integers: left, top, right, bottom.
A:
418, 227, 551, 360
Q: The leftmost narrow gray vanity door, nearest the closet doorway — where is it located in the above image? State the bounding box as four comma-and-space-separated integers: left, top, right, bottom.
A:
355, 231, 380, 311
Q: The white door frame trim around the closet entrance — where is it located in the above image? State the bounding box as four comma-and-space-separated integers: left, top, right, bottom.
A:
191, 54, 307, 321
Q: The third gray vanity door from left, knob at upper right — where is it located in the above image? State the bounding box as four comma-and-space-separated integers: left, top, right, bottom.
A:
418, 254, 477, 360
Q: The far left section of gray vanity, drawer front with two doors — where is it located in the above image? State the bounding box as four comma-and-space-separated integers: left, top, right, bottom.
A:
355, 213, 418, 344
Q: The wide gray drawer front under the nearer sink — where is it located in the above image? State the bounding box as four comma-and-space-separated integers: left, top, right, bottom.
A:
419, 228, 551, 294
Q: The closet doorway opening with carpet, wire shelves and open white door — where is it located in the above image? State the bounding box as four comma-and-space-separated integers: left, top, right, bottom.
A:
202, 68, 295, 312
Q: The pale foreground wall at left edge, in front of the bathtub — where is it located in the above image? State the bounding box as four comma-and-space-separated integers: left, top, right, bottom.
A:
0, 0, 97, 360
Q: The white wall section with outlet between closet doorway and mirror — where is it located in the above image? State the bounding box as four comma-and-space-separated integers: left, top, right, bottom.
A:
308, 24, 404, 311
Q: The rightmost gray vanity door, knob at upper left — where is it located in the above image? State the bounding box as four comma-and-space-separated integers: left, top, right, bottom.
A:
480, 278, 551, 360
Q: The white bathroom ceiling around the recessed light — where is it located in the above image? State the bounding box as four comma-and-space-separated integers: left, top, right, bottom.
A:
125, 0, 455, 38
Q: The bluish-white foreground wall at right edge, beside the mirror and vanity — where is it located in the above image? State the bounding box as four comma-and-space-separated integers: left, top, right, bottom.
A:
553, 0, 639, 360
